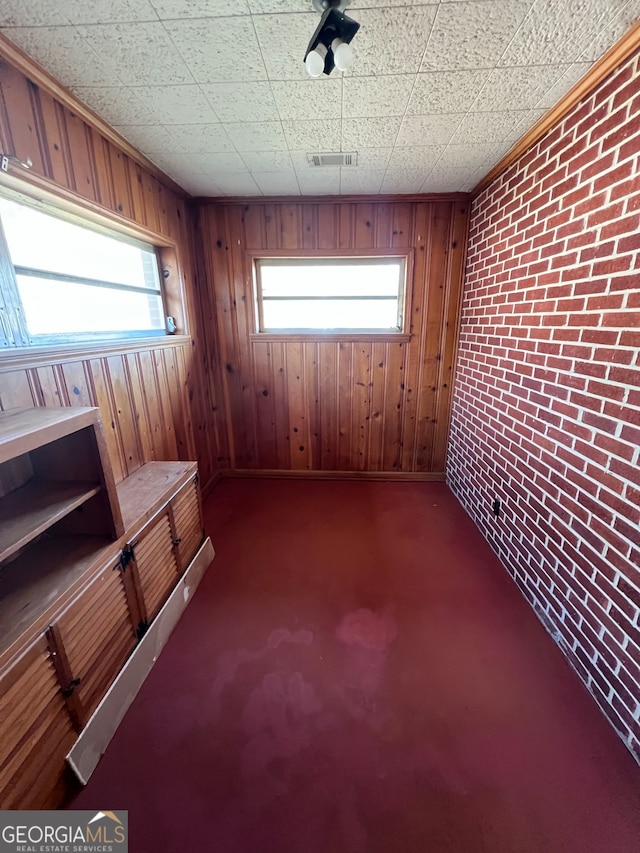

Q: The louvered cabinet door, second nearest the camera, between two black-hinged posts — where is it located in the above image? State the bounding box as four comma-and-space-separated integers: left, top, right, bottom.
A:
55, 563, 137, 723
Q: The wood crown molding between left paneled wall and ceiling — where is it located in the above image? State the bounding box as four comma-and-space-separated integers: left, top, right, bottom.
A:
0, 32, 191, 198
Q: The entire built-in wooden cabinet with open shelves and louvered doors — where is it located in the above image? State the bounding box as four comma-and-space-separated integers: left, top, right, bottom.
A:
0, 408, 204, 808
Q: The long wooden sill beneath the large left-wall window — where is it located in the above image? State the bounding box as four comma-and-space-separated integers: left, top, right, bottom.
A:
0, 335, 191, 372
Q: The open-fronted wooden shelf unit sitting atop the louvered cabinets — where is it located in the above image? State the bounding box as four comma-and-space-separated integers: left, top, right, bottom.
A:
0, 408, 124, 665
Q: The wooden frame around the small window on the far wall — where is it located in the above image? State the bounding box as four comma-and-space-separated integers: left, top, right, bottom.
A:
246, 249, 414, 342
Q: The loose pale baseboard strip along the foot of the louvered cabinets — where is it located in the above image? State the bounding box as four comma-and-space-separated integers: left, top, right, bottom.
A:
67, 537, 215, 785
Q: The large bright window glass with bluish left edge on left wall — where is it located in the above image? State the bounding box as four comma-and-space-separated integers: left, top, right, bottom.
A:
0, 196, 165, 346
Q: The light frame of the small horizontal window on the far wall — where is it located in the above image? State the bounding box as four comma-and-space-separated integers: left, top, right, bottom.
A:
248, 249, 413, 340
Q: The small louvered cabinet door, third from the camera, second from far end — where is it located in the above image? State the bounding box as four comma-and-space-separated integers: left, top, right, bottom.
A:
133, 512, 179, 622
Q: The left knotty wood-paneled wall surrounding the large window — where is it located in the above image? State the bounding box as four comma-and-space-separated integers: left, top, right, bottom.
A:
0, 43, 225, 488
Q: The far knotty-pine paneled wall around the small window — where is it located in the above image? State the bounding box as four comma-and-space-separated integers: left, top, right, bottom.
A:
199, 198, 468, 477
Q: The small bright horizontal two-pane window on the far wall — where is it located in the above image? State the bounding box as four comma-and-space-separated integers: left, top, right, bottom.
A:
256, 257, 406, 333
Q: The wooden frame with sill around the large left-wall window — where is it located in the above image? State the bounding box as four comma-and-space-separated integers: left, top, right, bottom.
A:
0, 180, 190, 352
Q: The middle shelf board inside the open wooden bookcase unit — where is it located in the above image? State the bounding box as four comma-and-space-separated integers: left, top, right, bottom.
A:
0, 481, 100, 562
